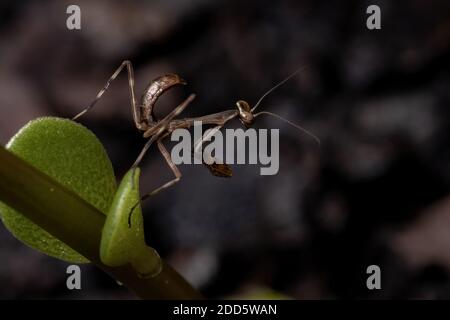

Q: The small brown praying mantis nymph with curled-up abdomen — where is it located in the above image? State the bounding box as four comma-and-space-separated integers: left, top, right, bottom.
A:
73, 60, 320, 200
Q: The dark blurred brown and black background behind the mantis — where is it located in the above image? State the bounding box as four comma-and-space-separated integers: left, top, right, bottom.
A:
0, 0, 450, 299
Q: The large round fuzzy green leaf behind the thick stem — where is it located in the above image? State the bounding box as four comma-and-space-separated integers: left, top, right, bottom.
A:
0, 117, 116, 263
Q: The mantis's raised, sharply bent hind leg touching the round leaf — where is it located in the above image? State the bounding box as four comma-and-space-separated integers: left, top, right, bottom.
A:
72, 60, 142, 129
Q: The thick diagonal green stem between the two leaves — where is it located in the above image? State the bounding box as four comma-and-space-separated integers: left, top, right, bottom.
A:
0, 146, 202, 299
